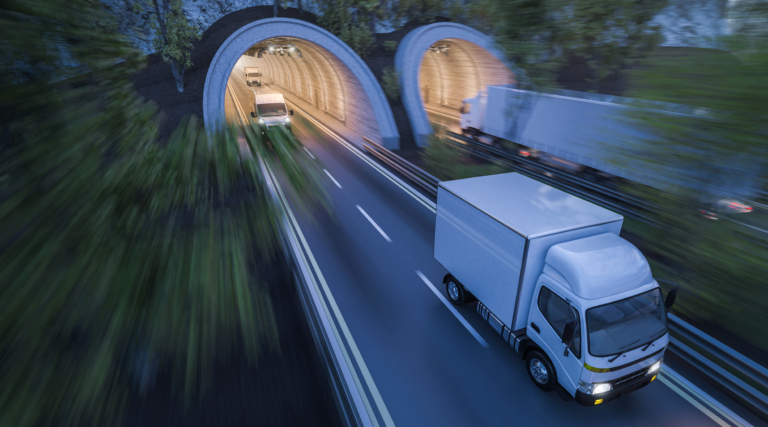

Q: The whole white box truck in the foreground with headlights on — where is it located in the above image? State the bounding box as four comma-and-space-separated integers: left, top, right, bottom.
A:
435, 173, 676, 406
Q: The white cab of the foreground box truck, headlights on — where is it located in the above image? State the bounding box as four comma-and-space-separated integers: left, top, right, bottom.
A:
521, 233, 669, 406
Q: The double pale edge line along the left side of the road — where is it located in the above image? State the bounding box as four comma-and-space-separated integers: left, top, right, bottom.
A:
227, 84, 395, 427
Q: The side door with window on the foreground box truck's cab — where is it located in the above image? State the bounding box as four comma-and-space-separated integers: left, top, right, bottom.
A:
528, 283, 584, 395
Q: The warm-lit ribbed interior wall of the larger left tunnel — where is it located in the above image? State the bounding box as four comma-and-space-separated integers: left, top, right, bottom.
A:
231, 40, 382, 143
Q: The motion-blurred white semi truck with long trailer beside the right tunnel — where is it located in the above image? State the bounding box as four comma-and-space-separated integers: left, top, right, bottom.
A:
460, 85, 653, 185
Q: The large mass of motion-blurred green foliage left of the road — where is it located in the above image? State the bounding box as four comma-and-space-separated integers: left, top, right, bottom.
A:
0, 0, 322, 427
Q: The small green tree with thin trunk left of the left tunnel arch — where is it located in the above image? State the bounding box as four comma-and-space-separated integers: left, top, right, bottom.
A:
152, 0, 201, 92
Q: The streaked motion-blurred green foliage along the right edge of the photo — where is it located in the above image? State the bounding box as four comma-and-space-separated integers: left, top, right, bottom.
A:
616, 1, 768, 351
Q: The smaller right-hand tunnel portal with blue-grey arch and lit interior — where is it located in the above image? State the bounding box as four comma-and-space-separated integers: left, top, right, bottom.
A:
395, 22, 516, 147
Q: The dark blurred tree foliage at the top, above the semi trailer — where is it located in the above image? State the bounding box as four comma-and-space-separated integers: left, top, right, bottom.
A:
464, 0, 668, 92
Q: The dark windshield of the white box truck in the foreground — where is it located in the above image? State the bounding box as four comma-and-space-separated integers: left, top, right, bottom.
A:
586, 288, 667, 357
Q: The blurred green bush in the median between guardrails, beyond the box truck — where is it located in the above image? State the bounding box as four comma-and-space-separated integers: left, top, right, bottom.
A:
421, 134, 512, 181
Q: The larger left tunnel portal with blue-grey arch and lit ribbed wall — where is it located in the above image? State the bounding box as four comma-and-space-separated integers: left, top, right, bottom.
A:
203, 18, 400, 149
